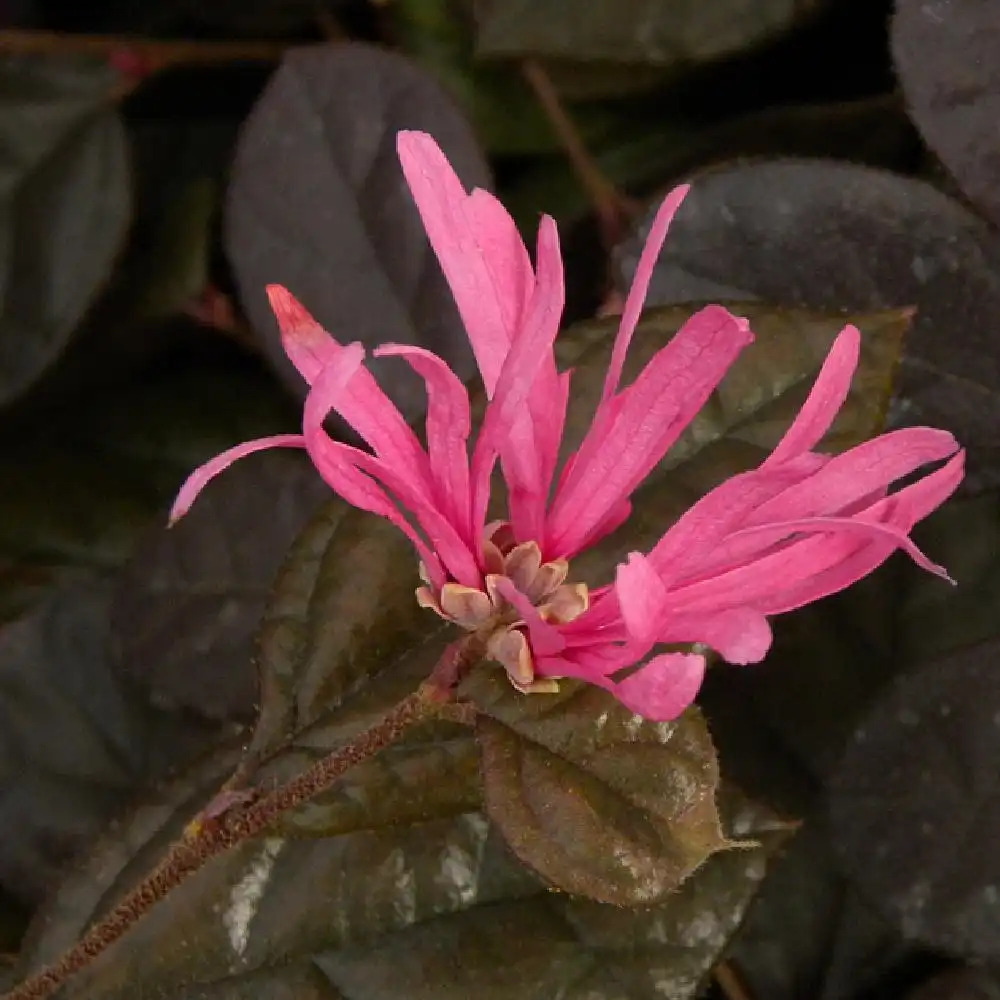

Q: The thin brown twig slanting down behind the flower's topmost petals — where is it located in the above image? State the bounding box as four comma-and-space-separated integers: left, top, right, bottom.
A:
521, 59, 639, 250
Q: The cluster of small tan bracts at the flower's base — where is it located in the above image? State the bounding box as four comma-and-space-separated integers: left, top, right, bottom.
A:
417, 521, 590, 692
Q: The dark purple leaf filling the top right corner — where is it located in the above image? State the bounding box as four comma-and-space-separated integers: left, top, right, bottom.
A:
892, 0, 1000, 223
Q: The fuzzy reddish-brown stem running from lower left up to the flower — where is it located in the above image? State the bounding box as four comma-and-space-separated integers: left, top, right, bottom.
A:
0, 635, 482, 1000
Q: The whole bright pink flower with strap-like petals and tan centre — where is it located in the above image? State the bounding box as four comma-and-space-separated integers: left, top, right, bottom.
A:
172, 132, 964, 719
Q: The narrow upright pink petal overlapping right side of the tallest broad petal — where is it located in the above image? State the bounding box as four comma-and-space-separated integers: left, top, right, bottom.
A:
472, 216, 565, 530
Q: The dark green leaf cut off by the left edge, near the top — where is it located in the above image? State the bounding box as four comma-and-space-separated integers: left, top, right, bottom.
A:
0, 57, 131, 402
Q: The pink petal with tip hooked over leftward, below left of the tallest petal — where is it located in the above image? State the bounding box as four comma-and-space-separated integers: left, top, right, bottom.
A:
374, 344, 478, 545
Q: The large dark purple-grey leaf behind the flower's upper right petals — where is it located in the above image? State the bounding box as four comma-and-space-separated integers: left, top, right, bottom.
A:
618, 161, 1000, 491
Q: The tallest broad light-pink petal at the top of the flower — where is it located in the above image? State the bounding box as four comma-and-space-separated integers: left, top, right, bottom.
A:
396, 131, 527, 396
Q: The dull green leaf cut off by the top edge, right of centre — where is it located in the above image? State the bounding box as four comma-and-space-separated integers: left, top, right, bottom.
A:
476, 0, 823, 67
